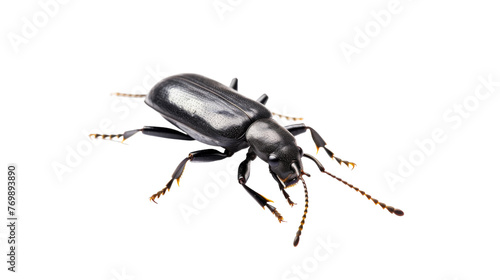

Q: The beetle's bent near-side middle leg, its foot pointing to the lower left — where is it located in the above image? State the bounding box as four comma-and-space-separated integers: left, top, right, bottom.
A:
149, 149, 233, 203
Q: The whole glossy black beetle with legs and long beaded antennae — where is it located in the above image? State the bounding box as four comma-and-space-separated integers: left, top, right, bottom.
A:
90, 74, 404, 246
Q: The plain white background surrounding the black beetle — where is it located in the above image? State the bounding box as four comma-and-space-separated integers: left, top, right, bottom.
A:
0, 0, 500, 280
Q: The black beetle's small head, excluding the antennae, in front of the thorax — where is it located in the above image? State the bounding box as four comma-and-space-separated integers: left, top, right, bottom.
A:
267, 145, 304, 188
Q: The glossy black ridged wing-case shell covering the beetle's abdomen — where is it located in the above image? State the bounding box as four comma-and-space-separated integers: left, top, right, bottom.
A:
145, 74, 272, 152
